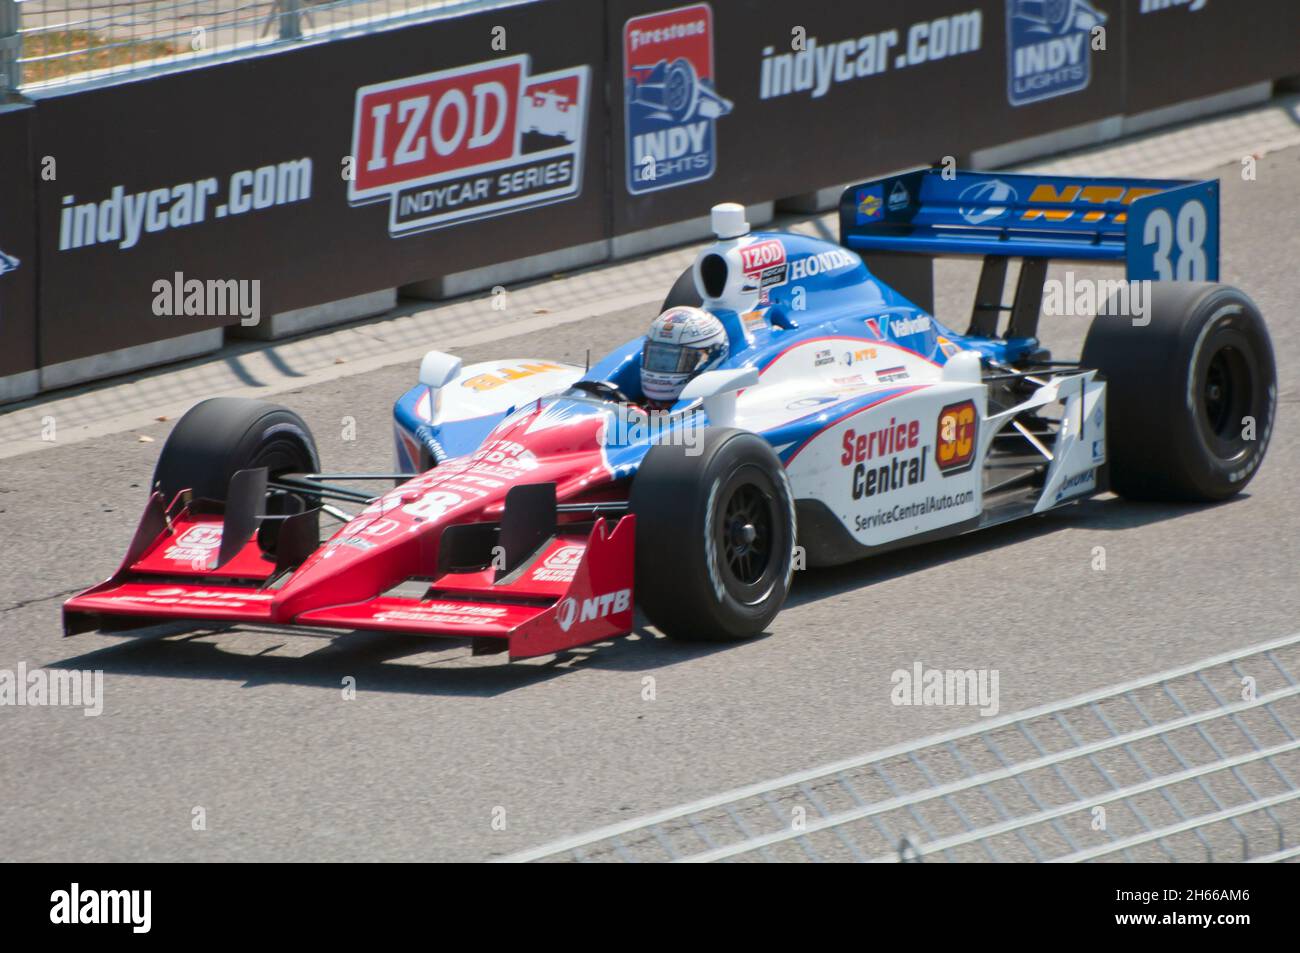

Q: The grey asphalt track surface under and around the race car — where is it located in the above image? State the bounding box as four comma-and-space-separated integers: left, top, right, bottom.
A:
0, 148, 1300, 861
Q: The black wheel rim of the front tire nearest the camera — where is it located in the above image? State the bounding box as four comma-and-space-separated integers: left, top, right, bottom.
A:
714, 471, 781, 606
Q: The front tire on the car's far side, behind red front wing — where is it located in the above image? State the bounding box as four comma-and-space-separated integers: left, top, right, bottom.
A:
152, 397, 320, 503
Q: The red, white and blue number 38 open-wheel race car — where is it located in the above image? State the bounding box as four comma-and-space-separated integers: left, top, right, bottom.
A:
64, 169, 1277, 659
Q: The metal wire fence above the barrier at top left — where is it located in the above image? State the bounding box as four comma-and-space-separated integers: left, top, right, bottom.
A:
0, 0, 501, 94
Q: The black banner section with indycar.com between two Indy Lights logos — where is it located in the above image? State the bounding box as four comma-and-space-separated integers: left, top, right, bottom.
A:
608, 0, 1123, 234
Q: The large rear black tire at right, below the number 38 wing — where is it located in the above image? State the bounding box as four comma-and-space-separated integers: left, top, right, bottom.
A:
1082, 282, 1278, 502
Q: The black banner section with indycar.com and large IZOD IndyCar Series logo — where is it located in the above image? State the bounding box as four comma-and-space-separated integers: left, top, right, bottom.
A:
36, 0, 608, 363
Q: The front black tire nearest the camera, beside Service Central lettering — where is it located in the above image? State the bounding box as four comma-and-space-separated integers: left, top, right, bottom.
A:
629, 428, 796, 641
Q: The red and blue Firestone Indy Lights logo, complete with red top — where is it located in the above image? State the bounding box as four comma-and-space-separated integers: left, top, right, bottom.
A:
623, 4, 732, 195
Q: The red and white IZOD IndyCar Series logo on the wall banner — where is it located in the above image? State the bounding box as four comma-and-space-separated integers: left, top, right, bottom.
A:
347, 56, 590, 237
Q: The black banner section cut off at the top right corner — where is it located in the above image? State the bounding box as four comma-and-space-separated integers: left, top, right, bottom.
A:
1125, 0, 1300, 113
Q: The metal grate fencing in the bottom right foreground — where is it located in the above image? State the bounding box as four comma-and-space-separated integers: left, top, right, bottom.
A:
506, 634, 1300, 863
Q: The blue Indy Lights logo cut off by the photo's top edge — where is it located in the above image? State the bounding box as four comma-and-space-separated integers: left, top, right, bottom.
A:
1006, 0, 1106, 105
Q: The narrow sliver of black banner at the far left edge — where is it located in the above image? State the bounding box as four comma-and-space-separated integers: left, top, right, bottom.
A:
0, 107, 36, 377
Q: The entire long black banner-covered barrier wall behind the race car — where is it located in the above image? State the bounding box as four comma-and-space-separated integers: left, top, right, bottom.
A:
0, 0, 1300, 399
